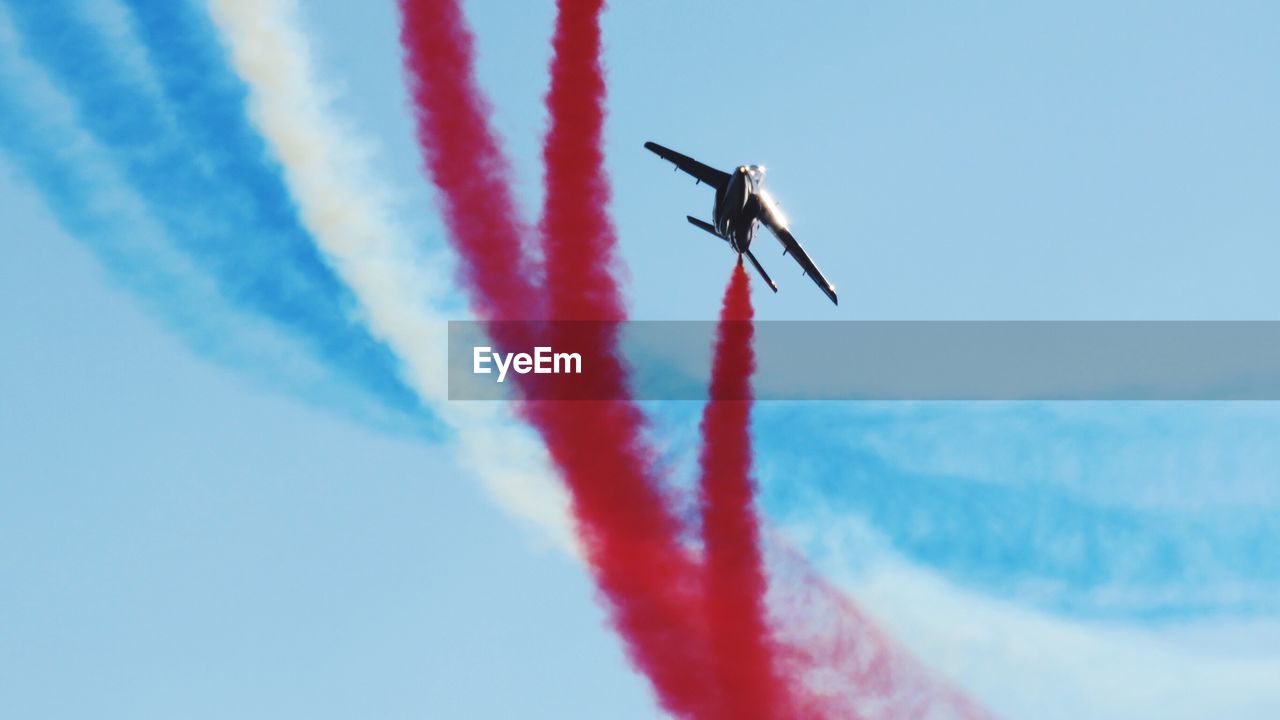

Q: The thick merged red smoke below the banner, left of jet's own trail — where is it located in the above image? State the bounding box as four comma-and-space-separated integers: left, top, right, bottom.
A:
529, 401, 717, 717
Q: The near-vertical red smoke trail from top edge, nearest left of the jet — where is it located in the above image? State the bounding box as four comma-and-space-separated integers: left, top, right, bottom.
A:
530, 0, 719, 716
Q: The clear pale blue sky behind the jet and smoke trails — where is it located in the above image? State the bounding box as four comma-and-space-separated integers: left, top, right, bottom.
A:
0, 0, 1280, 719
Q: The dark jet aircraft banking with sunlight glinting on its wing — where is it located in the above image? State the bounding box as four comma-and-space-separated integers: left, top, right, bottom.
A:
644, 142, 840, 305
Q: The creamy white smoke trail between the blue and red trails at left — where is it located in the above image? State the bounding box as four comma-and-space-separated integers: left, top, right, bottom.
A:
209, 0, 576, 553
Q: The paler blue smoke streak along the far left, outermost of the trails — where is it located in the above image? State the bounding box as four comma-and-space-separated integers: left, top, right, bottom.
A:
0, 53, 433, 433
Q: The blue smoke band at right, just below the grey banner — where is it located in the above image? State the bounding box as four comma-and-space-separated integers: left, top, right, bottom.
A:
755, 404, 1280, 621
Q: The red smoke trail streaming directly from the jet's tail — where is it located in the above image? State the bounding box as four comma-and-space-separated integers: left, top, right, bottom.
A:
699, 258, 792, 720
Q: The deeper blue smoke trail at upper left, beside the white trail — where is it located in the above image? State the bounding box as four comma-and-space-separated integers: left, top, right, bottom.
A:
6, 0, 424, 416
